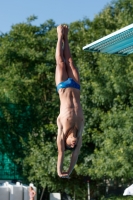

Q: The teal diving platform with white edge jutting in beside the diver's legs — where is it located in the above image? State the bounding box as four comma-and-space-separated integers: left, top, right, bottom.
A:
83, 24, 133, 56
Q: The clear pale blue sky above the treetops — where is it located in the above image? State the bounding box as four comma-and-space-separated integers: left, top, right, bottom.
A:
0, 0, 111, 33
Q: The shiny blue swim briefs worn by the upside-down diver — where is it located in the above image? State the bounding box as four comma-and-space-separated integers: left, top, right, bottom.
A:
57, 78, 80, 91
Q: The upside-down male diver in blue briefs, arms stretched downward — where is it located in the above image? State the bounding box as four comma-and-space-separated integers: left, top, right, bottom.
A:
55, 25, 84, 178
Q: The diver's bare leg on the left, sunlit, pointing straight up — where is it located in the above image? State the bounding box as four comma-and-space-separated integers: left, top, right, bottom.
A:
55, 25, 68, 85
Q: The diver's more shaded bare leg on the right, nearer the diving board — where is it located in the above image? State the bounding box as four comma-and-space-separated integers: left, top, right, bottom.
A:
63, 25, 80, 83
